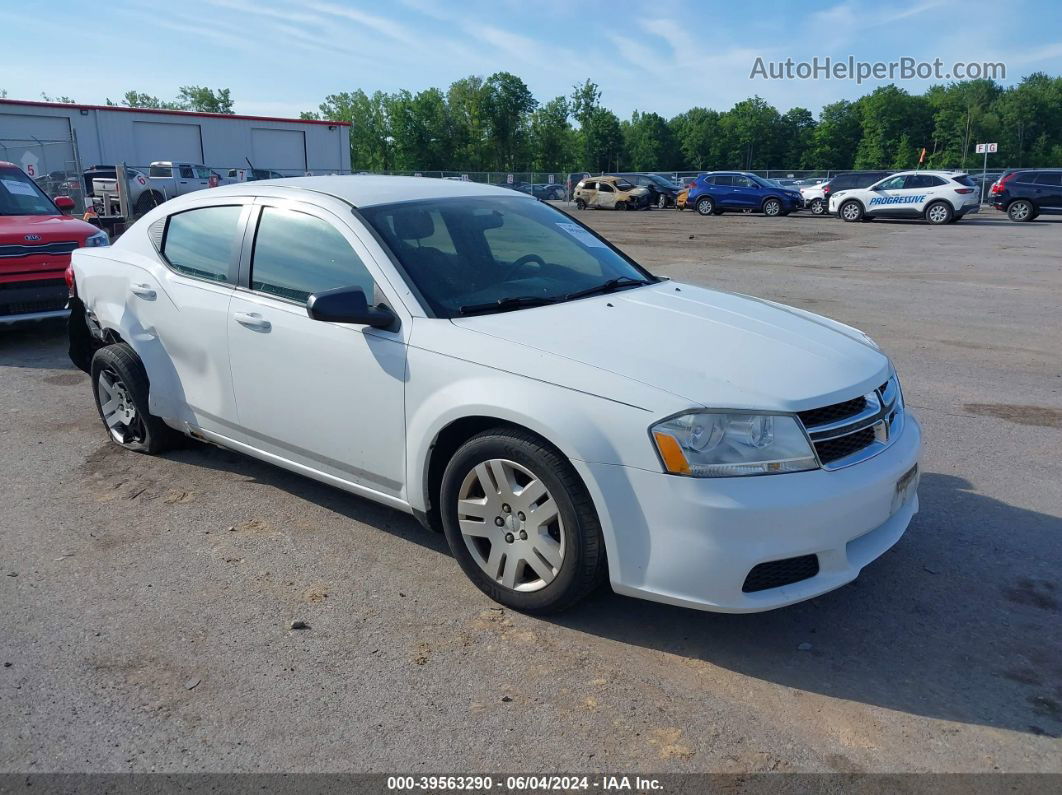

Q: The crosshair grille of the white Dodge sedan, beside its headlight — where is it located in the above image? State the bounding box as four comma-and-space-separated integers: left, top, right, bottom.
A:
797, 376, 904, 469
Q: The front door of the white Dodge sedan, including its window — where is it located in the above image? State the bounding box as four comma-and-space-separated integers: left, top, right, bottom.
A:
228, 200, 406, 497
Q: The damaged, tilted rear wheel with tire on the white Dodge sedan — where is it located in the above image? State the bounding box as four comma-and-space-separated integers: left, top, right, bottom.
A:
90, 343, 179, 454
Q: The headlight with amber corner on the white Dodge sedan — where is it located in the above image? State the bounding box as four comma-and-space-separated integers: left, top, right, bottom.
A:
649, 412, 819, 478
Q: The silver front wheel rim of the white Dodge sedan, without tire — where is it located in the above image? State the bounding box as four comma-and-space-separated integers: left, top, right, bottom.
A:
458, 459, 566, 592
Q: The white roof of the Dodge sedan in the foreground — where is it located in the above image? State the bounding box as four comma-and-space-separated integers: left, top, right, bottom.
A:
201, 174, 526, 207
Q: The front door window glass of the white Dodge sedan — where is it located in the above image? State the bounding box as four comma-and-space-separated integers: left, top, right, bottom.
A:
251, 207, 375, 304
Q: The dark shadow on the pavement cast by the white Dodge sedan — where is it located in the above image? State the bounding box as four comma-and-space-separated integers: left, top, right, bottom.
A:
157, 442, 1062, 737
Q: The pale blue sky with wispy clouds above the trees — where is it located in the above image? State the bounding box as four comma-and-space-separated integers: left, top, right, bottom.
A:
0, 0, 1062, 118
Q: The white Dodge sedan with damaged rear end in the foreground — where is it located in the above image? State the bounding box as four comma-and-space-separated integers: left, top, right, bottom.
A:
70, 176, 921, 612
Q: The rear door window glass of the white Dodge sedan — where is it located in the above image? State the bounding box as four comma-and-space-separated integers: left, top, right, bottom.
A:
162, 205, 243, 281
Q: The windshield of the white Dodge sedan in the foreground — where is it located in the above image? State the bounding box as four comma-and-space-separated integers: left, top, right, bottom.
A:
361, 196, 655, 317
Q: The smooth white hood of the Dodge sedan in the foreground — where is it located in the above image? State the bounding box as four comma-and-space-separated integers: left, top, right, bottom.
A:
452, 281, 891, 412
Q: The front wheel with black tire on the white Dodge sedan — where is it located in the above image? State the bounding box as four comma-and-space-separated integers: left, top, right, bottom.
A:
439, 428, 607, 615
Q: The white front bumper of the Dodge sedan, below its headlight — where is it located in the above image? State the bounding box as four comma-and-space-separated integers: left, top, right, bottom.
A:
575, 413, 922, 612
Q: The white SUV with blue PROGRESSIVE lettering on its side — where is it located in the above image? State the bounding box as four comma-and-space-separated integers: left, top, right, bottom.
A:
829, 171, 981, 224
